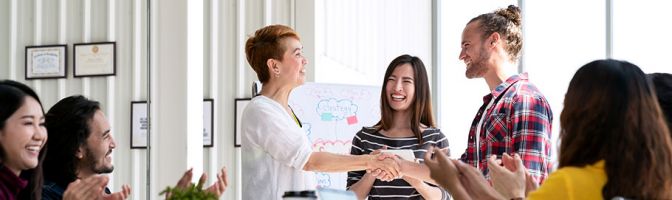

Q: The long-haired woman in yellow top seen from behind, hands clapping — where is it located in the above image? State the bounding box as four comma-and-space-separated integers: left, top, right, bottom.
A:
425, 60, 672, 199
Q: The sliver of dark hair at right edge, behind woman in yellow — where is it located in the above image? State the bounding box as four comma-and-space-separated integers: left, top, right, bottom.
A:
648, 73, 672, 129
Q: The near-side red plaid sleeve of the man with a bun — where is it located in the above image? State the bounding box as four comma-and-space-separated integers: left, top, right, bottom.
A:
511, 95, 553, 183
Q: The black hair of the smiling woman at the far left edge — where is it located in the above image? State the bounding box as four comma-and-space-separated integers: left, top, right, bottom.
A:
0, 80, 47, 200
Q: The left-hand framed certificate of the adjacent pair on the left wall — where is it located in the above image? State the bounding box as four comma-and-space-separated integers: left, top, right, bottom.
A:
25, 44, 68, 80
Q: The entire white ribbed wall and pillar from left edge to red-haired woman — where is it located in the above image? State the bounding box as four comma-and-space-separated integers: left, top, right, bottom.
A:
0, 0, 304, 199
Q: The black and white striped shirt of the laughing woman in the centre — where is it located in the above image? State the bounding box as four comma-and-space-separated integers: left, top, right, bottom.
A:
347, 127, 448, 200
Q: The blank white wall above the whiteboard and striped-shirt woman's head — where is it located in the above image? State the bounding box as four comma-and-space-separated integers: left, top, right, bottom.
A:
309, 0, 436, 86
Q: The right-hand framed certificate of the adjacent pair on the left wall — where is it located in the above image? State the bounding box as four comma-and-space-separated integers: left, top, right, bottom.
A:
72, 42, 117, 77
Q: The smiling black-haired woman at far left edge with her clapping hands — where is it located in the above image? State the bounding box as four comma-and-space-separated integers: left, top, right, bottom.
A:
0, 80, 109, 200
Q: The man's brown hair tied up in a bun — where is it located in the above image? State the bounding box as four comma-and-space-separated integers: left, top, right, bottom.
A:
467, 5, 523, 61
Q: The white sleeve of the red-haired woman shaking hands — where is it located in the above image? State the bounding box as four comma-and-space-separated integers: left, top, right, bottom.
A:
241, 102, 312, 170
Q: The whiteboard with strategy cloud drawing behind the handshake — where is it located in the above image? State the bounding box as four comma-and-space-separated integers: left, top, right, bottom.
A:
289, 83, 381, 190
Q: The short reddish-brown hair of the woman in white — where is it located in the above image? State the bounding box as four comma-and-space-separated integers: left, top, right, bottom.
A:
245, 25, 300, 83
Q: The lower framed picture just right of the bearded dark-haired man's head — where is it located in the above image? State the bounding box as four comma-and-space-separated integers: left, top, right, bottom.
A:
130, 101, 149, 149
